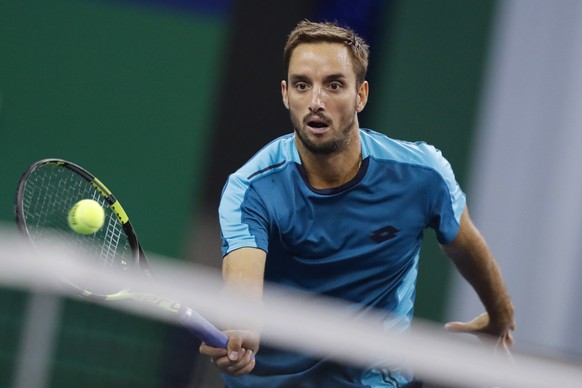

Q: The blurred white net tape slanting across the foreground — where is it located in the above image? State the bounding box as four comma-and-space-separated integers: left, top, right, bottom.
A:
0, 232, 582, 387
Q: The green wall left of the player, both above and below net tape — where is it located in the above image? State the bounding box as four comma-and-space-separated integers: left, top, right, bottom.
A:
0, 0, 228, 387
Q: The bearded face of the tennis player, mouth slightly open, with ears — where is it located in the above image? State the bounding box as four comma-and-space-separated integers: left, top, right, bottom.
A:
281, 43, 368, 154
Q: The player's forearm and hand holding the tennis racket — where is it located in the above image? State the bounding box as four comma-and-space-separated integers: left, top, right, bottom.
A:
200, 248, 267, 376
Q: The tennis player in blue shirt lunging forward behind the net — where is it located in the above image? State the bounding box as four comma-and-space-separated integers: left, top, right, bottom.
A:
200, 21, 514, 387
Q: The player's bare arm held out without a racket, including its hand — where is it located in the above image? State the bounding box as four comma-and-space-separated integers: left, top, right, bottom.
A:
442, 208, 515, 347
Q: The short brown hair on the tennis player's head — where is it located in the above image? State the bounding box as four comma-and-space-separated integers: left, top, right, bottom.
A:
283, 20, 369, 86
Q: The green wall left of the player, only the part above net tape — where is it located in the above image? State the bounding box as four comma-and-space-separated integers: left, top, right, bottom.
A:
0, 0, 227, 256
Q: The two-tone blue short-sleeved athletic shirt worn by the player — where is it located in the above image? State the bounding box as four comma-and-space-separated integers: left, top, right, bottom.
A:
219, 129, 465, 388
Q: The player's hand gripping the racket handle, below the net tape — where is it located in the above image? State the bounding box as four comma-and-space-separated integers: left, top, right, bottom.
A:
200, 330, 259, 376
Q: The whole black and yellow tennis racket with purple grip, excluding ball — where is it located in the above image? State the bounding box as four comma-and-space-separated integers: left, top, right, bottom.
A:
14, 159, 228, 348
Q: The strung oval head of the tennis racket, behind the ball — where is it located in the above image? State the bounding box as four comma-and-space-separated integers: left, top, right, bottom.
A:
14, 158, 149, 298
